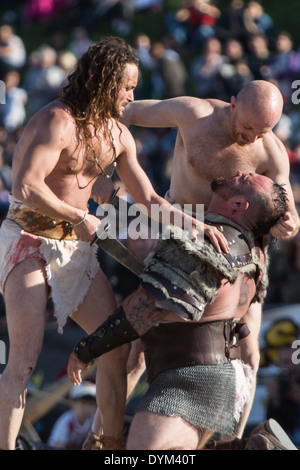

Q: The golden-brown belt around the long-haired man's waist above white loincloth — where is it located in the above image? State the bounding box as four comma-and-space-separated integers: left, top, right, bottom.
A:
6, 207, 77, 240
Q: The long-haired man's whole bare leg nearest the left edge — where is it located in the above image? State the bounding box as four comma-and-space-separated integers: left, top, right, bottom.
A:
0, 259, 48, 450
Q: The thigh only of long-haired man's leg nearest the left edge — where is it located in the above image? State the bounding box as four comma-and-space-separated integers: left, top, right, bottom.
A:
4, 258, 48, 357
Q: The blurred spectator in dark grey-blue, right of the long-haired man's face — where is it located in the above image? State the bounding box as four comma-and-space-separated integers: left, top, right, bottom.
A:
150, 42, 187, 99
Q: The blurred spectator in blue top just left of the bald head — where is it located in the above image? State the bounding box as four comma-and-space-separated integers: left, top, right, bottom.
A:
191, 38, 227, 98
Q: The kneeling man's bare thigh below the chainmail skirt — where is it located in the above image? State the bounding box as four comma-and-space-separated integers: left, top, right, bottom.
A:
127, 411, 199, 450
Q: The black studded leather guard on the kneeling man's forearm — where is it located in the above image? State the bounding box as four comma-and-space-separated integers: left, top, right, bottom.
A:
74, 307, 139, 364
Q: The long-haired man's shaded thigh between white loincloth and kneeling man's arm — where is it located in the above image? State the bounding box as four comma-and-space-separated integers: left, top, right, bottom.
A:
71, 268, 117, 334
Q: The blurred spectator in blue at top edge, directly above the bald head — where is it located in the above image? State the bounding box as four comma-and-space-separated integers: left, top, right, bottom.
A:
245, 1, 274, 40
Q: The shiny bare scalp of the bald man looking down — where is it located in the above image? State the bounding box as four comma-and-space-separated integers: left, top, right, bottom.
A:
237, 80, 283, 128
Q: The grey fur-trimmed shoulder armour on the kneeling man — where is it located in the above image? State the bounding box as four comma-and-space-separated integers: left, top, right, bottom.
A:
141, 218, 264, 321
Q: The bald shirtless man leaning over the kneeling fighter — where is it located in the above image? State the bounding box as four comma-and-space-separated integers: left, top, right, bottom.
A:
122, 80, 299, 432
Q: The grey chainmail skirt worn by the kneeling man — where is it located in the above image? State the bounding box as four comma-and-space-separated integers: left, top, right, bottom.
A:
136, 361, 253, 436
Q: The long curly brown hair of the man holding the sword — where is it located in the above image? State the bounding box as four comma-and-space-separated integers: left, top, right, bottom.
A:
59, 37, 138, 152
